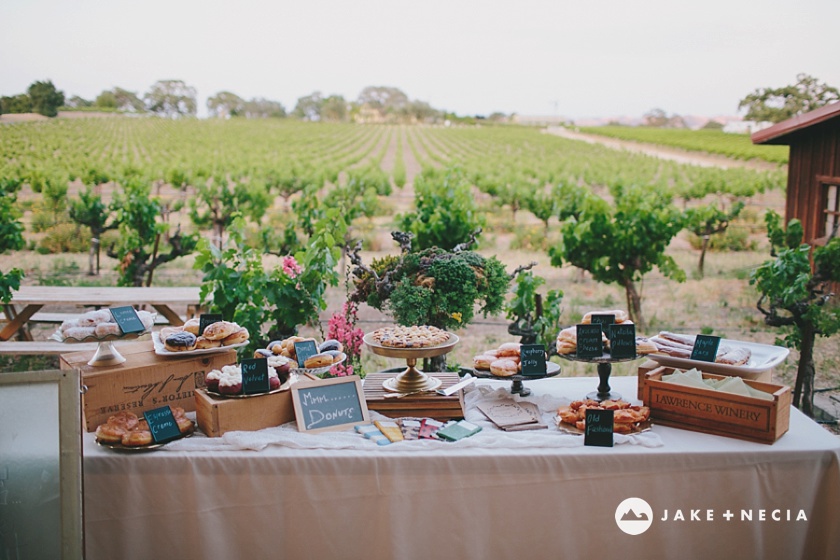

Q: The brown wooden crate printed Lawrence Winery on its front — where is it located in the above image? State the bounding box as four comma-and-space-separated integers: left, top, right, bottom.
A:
642, 367, 791, 443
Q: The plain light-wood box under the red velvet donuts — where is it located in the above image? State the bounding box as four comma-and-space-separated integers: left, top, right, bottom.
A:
195, 389, 295, 437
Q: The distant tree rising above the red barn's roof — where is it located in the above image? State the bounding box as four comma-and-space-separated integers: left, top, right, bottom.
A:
738, 74, 840, 123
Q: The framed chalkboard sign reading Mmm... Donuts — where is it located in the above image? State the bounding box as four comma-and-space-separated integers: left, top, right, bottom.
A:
291, 375, 370, 432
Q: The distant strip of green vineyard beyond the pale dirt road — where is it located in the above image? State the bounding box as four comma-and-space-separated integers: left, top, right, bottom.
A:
580, 126, 788, 164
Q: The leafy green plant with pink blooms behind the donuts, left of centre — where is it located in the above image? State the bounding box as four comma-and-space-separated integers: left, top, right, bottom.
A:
194, 210, 345, 355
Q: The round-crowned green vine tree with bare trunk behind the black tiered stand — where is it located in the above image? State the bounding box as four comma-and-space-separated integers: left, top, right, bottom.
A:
549, 185, 685, 331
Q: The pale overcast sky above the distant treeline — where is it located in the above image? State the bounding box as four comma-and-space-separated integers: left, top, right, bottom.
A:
0, 0, 840, 118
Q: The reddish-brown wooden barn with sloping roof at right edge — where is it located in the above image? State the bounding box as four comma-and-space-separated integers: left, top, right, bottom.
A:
751, 102, 840, 245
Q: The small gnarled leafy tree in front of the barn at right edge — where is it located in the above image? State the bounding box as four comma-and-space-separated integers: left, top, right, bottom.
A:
750, 211, 840, 417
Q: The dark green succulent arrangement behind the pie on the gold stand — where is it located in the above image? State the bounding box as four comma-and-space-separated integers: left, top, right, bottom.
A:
352, 243, 510, 329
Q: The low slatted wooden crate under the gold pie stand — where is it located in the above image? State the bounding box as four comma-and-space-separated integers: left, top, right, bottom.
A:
364, 372, 464, 421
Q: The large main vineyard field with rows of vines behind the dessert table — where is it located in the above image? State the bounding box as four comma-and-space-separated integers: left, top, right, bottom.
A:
0, 118, 840, 406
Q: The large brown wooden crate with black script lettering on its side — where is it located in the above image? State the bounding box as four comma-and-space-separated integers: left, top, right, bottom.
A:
61, 341, 236, 432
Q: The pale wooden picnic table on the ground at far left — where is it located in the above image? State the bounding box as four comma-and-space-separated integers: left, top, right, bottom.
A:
0, 286, 200, 348
